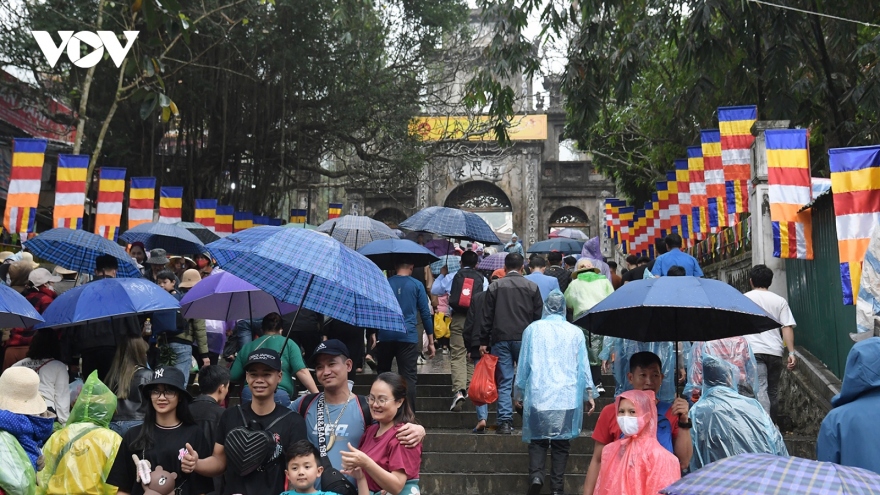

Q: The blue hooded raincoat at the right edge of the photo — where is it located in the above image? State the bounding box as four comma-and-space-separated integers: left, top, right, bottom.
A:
816, 337, 880, 474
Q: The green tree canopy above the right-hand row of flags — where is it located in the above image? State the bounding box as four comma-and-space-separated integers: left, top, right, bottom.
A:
470, 0, 880, 204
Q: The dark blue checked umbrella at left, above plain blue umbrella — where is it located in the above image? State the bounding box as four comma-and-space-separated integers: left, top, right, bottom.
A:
24, 228, 141, 278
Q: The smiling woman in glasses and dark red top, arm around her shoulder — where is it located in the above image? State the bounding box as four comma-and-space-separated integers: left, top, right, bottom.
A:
342, 373, 422, 495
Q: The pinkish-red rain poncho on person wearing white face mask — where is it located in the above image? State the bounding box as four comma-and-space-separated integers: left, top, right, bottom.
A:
593, 390, 681, 495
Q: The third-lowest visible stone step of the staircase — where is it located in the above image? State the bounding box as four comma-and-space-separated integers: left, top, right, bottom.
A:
422, 432, 593, 456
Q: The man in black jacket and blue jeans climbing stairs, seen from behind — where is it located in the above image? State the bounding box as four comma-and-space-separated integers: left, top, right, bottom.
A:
480, 253, 544, 435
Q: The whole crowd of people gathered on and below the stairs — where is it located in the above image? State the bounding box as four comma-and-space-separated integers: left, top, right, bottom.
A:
0, 230, 880, 495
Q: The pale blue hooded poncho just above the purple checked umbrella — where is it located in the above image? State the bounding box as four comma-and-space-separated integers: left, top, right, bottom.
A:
690, 355, 788, 470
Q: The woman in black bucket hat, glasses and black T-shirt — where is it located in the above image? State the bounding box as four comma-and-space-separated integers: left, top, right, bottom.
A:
107, 366, 214, 495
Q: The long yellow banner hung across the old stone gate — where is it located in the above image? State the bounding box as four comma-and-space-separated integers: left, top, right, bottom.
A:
410, 115, 547, 141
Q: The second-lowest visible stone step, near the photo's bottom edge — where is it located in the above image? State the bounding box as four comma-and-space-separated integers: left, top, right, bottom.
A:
421, 452, 591, 474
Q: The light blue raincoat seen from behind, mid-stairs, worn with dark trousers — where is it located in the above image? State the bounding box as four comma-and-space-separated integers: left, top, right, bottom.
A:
515, 290, 595, 443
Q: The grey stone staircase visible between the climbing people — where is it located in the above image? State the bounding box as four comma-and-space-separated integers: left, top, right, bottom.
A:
354, 364, 613, 495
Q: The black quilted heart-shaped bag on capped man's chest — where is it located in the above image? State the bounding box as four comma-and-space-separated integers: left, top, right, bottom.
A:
224, 406, 293, 476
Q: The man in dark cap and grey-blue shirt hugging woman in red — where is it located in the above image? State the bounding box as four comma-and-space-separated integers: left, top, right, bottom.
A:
290, 339, 425, 490
